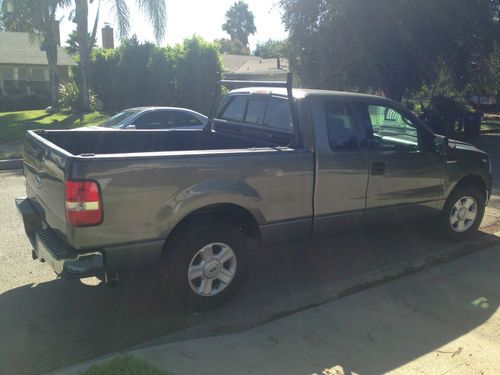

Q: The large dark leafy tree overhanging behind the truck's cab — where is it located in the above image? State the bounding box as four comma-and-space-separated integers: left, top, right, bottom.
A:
280, 0, 498, 100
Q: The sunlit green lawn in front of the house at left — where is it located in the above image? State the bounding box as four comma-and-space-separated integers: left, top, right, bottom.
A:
0, 110, 109, 141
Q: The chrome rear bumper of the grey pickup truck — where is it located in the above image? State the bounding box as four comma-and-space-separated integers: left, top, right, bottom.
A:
16, 197, 104, 279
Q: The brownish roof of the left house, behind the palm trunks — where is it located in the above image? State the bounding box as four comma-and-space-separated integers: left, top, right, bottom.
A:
0, 32, 76, 66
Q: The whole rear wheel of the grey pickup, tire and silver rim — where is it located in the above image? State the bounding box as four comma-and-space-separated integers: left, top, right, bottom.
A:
164, 222, 248, 310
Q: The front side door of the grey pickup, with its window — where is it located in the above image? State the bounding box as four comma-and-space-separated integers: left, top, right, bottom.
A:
360, 101, 443, 223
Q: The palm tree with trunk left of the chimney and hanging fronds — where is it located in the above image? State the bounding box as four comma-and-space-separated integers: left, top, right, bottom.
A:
74, 0, 167, 111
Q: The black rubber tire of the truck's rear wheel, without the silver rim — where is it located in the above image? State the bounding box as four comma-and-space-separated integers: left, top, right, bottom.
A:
162, 221, 249, 311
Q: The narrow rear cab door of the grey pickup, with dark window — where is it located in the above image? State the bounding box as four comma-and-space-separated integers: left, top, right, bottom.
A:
311, 96, 370, 235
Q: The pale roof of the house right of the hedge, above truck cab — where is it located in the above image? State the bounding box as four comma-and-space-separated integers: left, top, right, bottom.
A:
222, 55, 288, 74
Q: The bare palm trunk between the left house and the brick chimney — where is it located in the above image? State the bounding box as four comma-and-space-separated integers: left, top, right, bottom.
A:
75, 0, 92, 112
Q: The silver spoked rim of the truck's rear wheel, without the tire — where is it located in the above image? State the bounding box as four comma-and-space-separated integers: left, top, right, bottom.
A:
187, 243, 236, 297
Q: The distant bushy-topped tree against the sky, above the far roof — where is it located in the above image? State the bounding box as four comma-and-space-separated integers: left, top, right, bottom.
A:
222, 0, 257, 47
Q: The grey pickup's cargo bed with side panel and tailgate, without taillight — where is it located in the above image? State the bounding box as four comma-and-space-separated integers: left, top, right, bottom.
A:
24, 130, 314, 256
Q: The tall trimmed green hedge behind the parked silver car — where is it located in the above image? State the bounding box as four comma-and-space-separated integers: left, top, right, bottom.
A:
87, 37, 222, 113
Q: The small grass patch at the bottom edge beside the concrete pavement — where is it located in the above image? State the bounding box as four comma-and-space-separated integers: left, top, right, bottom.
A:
81, 356, 168, 375
